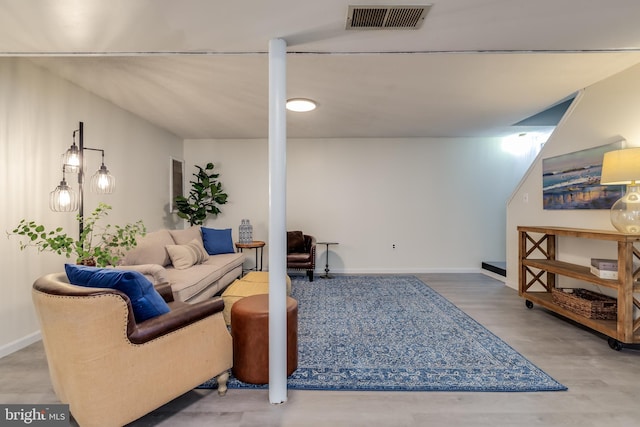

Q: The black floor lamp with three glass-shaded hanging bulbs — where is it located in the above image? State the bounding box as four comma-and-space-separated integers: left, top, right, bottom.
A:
49, 122, 116, 237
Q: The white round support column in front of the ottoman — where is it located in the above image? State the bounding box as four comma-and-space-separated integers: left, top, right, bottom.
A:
269, 39, 287, 403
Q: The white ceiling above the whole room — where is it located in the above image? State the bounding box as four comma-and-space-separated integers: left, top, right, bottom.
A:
0, 0, 640, 138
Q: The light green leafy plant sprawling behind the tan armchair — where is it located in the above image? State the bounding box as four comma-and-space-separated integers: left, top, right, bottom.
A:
7, 203, 147, 267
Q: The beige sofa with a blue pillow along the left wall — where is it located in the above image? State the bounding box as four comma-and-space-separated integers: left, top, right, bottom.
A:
119, 226, 245, 303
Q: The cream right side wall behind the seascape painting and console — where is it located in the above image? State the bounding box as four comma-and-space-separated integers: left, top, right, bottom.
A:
507, 66, 640, 288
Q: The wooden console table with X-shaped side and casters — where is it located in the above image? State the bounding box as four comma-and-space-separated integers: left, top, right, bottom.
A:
518, 226, 640, 350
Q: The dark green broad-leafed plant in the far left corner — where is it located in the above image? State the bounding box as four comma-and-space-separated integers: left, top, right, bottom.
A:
176, 163, 228, 225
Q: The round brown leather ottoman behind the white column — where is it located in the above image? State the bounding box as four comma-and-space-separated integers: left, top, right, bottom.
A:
231, 294, 298, 384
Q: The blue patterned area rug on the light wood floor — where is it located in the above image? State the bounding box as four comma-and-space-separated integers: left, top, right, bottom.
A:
201, 276, 567, 392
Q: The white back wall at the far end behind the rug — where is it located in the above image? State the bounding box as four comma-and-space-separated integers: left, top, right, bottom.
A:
185, 138, 530, 273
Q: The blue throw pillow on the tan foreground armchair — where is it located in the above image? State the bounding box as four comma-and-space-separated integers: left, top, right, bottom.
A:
64, 264, 170, 322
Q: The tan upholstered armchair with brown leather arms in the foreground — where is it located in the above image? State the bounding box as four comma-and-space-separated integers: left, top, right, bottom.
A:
32, 273, 233, 427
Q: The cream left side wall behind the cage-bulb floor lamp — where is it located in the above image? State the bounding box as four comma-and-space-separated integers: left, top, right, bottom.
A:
0, 58, 182, 357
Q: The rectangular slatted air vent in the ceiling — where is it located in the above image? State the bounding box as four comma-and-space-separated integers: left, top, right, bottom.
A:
347, 4, 431, 30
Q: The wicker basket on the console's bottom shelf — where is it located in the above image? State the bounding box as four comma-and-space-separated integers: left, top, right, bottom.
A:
552, 288, 618, 320
